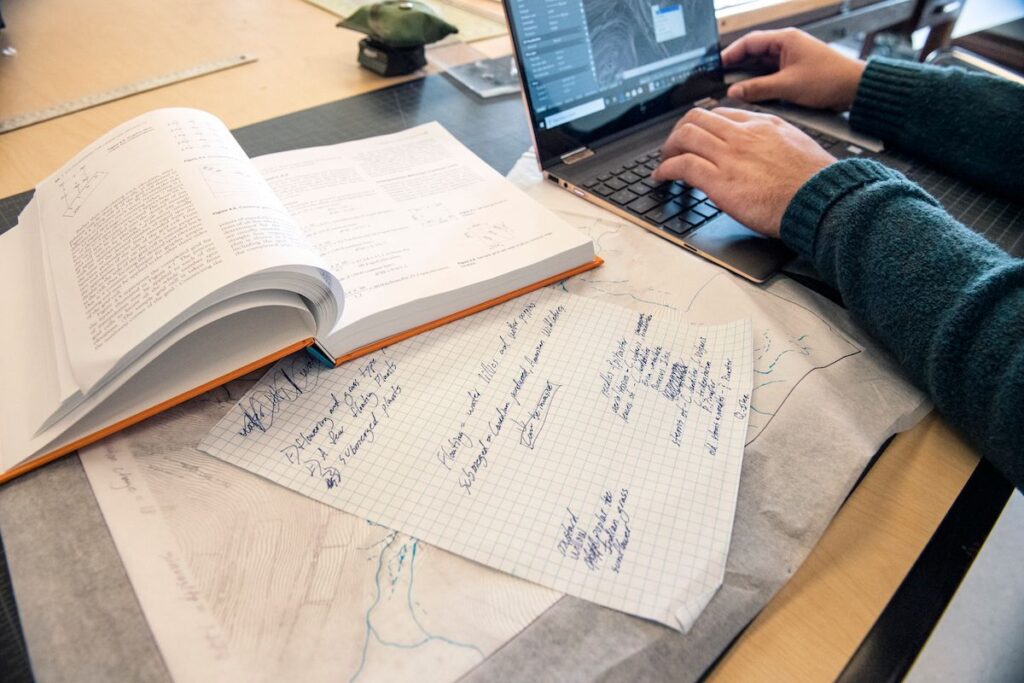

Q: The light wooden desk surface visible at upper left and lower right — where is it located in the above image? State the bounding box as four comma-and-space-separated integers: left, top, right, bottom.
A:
0, 0, 977, 681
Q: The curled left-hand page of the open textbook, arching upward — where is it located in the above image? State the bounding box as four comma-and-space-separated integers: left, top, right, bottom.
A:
36, 109, 340, 394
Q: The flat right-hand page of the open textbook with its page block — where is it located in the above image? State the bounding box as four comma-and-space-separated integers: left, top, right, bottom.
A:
253, 122, 594, 355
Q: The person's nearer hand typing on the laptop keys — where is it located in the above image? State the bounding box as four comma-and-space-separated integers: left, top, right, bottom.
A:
651, 106, 836, 238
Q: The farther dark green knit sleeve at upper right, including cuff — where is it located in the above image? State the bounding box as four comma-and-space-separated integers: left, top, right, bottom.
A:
850, 58, 1024, 201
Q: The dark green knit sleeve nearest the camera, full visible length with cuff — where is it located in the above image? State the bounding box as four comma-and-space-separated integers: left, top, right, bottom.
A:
781, 160, 1024, 488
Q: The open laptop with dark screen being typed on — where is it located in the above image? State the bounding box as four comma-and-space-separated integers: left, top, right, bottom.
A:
504, 0, 792, 283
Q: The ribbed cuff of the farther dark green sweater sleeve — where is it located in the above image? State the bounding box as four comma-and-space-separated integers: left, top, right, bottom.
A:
850, 57, 925, 140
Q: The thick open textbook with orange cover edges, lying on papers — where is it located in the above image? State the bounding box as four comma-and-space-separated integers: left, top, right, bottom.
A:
0, 109, 600, 481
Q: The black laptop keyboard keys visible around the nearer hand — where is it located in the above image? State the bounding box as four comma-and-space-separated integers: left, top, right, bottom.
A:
583, 113, 864, 236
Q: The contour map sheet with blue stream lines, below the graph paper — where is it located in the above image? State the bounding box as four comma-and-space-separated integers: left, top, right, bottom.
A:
81, 389, 560, 681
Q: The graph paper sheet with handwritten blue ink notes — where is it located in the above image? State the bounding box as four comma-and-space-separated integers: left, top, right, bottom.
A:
200, 289, 753, 631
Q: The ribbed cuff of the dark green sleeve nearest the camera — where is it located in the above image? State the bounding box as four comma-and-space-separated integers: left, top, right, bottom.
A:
779, 159, 902, 260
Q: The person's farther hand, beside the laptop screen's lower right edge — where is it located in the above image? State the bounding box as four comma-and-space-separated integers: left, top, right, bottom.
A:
722, 29, 864, 112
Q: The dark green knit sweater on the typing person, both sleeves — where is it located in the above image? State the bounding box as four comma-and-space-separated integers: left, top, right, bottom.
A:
781, 59, 1024, 488
